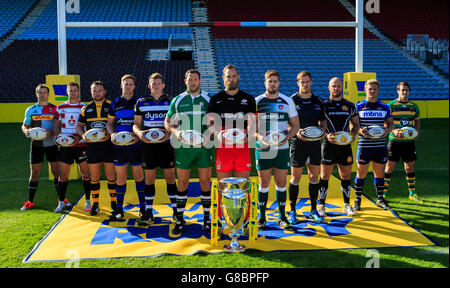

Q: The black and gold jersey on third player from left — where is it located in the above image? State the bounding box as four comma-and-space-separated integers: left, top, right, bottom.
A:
78, 100, 111, 131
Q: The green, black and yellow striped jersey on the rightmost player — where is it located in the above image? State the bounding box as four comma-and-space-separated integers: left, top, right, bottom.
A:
388, 99, 420, 142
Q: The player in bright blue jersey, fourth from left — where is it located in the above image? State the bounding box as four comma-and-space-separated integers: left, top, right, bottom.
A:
106, 74, 144, 224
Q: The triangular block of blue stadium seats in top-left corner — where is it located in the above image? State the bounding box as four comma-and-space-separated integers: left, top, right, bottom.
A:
0, 0, 36, 38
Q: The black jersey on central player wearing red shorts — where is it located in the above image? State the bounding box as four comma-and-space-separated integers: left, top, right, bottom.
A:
208, 90, 256, 129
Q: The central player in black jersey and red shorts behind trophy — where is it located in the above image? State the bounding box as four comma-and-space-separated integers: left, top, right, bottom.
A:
207, 65, 256, 232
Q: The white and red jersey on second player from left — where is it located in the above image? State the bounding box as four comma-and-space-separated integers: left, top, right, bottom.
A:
56, 101, 86, 147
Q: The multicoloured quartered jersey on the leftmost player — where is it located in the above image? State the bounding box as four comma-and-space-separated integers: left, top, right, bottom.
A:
23, 103, 58, 147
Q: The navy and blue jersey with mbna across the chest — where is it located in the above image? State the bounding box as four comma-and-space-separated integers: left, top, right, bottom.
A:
356, 100, 392, 148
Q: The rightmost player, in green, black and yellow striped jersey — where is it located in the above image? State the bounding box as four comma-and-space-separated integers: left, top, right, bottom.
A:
384, 82, 423, 203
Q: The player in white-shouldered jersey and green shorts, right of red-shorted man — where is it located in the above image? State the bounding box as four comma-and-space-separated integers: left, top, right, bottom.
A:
254, 70, 300, 230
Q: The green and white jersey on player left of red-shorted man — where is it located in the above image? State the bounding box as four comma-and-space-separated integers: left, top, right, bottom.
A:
167, 90, 210, 133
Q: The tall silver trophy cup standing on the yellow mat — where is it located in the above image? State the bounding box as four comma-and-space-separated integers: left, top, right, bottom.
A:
219, 177, 251, 252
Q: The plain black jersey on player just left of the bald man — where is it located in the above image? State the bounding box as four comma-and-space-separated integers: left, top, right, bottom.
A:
291, 92, 326, 128
